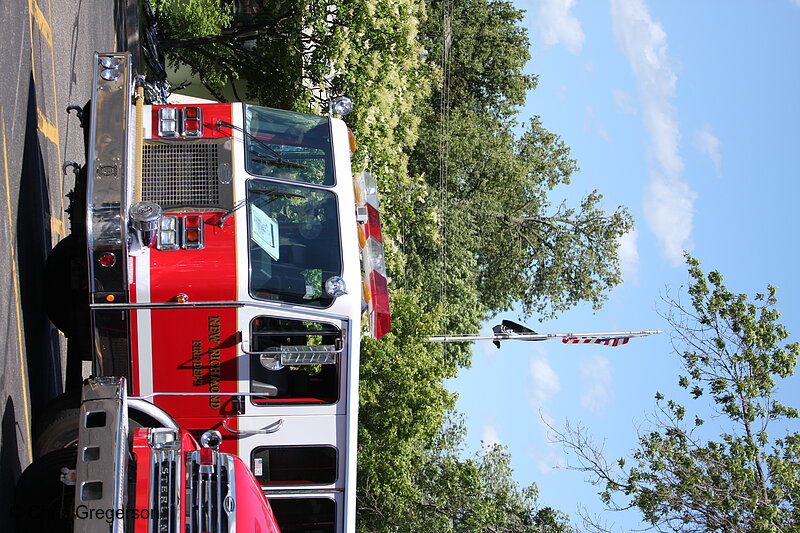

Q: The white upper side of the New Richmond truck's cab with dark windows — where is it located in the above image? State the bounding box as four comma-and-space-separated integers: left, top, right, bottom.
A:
237, 309, 358, 533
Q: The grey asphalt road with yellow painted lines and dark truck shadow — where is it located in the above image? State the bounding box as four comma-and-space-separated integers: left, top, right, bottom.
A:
0, 0, 135, 531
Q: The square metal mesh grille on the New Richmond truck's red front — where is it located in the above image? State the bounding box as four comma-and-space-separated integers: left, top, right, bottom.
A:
142, 141, 220, 209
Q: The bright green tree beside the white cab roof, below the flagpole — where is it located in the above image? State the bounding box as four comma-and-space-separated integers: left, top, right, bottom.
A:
358, 290, 455, 531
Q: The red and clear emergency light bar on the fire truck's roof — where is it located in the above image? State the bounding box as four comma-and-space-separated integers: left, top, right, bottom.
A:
355, 171, 391, 339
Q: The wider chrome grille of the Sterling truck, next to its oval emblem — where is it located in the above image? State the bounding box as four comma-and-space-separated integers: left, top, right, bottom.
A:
186, 452, 236, 533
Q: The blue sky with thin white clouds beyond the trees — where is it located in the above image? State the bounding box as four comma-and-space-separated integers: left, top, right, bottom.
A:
448, 0, 800, 531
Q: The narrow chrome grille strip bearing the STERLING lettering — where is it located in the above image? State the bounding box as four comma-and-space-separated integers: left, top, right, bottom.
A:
150, 449, 182, 533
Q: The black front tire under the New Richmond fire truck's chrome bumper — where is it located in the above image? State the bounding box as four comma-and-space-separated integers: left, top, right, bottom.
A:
44, 235, 79, 337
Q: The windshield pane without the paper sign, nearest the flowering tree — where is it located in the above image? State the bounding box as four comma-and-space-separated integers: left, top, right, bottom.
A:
245, 105, 334, 185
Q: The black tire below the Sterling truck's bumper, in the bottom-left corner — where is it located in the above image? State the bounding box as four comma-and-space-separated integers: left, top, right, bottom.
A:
12, 448, 77, 533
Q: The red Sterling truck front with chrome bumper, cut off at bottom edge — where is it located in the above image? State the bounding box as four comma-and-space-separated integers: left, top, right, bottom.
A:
12, 378, 279, 533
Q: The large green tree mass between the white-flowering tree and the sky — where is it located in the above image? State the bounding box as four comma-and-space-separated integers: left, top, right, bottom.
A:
398, 0, 633, 354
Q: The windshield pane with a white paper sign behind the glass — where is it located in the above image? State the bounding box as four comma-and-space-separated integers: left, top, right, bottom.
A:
247, 179, 342, 307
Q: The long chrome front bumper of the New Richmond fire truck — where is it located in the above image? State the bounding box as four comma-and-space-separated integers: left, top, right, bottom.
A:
86, 53, 136, 376
